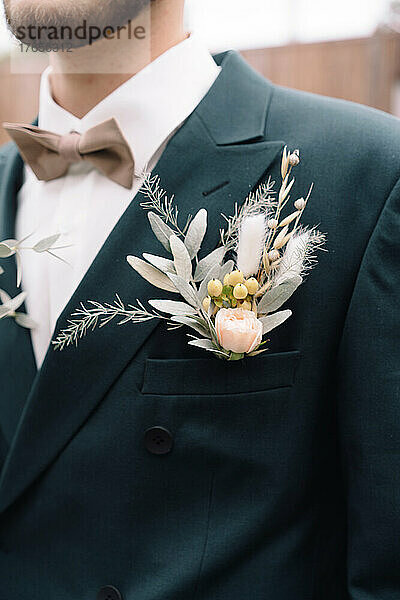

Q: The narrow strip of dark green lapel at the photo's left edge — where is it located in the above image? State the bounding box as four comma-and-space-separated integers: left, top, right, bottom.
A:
0, 146, 36, 444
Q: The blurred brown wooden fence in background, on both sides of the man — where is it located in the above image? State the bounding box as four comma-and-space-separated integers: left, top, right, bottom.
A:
0, 31, 400, 143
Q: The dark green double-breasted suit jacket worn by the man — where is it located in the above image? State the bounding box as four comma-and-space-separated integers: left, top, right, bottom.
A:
0, 52, 400, 600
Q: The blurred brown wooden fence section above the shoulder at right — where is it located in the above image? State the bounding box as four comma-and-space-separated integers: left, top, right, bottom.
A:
242, 31, 400, 116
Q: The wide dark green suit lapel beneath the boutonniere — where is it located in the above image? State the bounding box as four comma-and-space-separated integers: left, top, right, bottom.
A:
0, 53, 284, 510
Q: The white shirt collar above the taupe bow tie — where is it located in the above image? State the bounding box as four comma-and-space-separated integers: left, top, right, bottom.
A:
39, 36, 220, 172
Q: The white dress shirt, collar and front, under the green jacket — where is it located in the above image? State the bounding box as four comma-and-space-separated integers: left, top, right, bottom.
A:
16, 37, 220, 367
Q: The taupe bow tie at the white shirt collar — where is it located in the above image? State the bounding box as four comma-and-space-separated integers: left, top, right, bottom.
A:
3, 118, 135, 188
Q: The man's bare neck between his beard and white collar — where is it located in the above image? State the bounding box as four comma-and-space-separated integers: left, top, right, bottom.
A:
46, 0, 187, 118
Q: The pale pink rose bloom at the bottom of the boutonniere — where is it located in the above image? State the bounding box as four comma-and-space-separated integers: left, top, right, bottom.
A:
215, 308, 263, 354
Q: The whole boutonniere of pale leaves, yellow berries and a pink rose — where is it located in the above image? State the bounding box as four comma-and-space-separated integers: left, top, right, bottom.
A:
52, 148, 325, 360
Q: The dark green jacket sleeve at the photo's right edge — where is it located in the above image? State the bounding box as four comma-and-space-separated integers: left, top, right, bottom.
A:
337, 175, 400, 600
